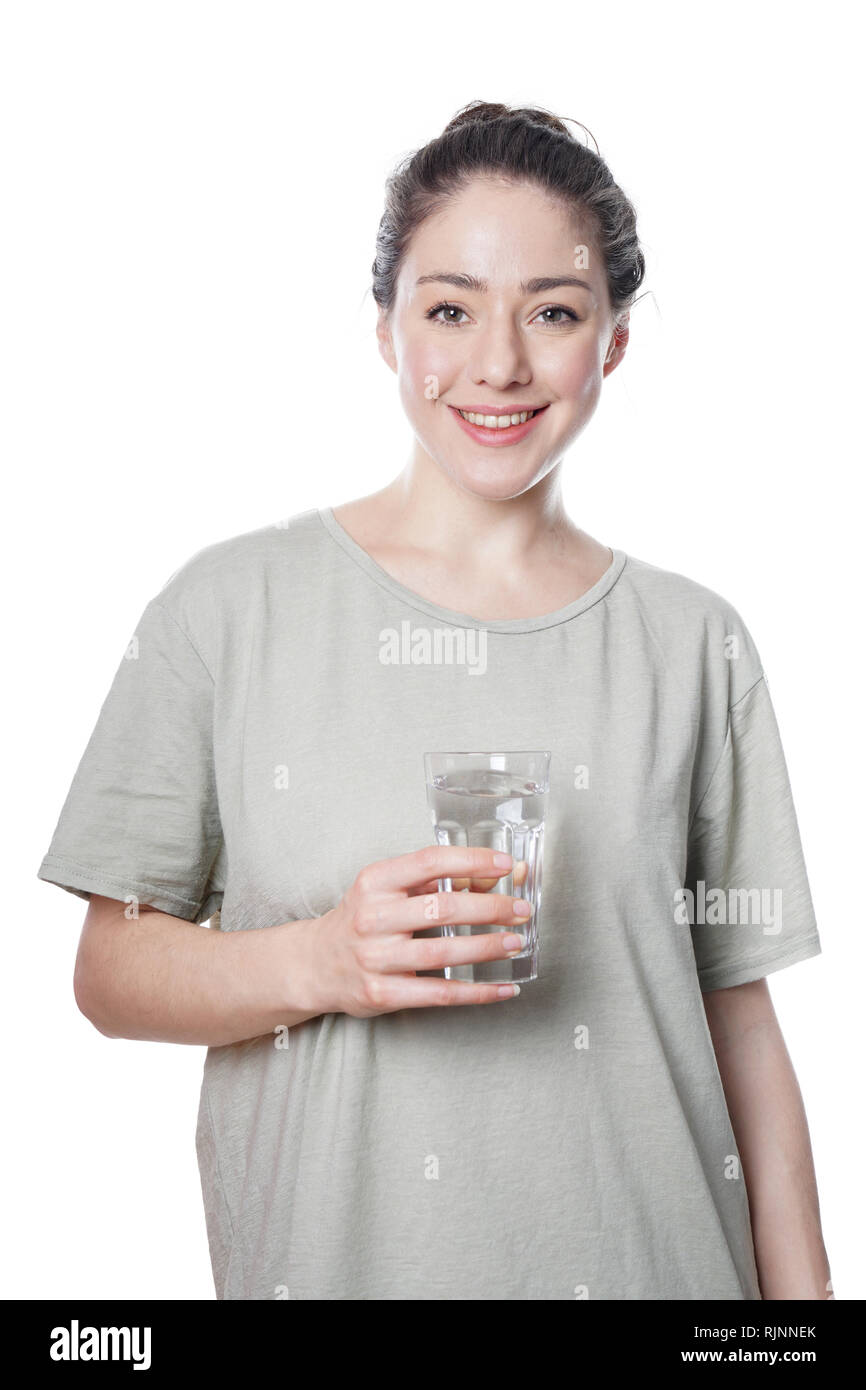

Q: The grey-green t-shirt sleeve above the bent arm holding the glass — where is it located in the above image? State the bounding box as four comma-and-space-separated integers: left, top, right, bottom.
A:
38, 599, 222, 922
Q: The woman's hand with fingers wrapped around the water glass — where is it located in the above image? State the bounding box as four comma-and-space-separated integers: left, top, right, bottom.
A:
313, 845, 530, 1019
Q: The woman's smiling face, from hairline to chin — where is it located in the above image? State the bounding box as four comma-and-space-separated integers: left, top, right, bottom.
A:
378, 178, 628, 500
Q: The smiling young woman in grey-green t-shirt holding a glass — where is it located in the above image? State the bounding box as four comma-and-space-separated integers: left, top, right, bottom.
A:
40, 103, 830, 1300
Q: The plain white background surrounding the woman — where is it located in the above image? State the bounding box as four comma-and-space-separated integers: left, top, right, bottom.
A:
0, 0, 866, 1298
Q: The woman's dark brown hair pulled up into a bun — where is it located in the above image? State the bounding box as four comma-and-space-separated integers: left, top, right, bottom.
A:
373, 101, 646, 322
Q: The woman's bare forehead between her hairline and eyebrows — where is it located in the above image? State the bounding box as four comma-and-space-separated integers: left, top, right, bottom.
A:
400, 177, 601, 292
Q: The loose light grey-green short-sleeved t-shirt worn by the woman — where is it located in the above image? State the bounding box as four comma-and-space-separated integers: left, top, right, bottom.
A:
39, 507, 820, 1300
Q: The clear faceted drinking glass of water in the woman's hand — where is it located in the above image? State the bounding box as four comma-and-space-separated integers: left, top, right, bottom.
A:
424, 751, 550, 984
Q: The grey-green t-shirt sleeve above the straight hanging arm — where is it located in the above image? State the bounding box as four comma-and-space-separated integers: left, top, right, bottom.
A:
685, 676, 822, 991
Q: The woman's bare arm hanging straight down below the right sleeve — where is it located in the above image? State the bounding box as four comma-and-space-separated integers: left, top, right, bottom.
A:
712, 981, 830, 1300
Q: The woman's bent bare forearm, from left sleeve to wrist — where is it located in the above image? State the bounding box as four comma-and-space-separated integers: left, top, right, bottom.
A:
75, 899, 324, 1047
